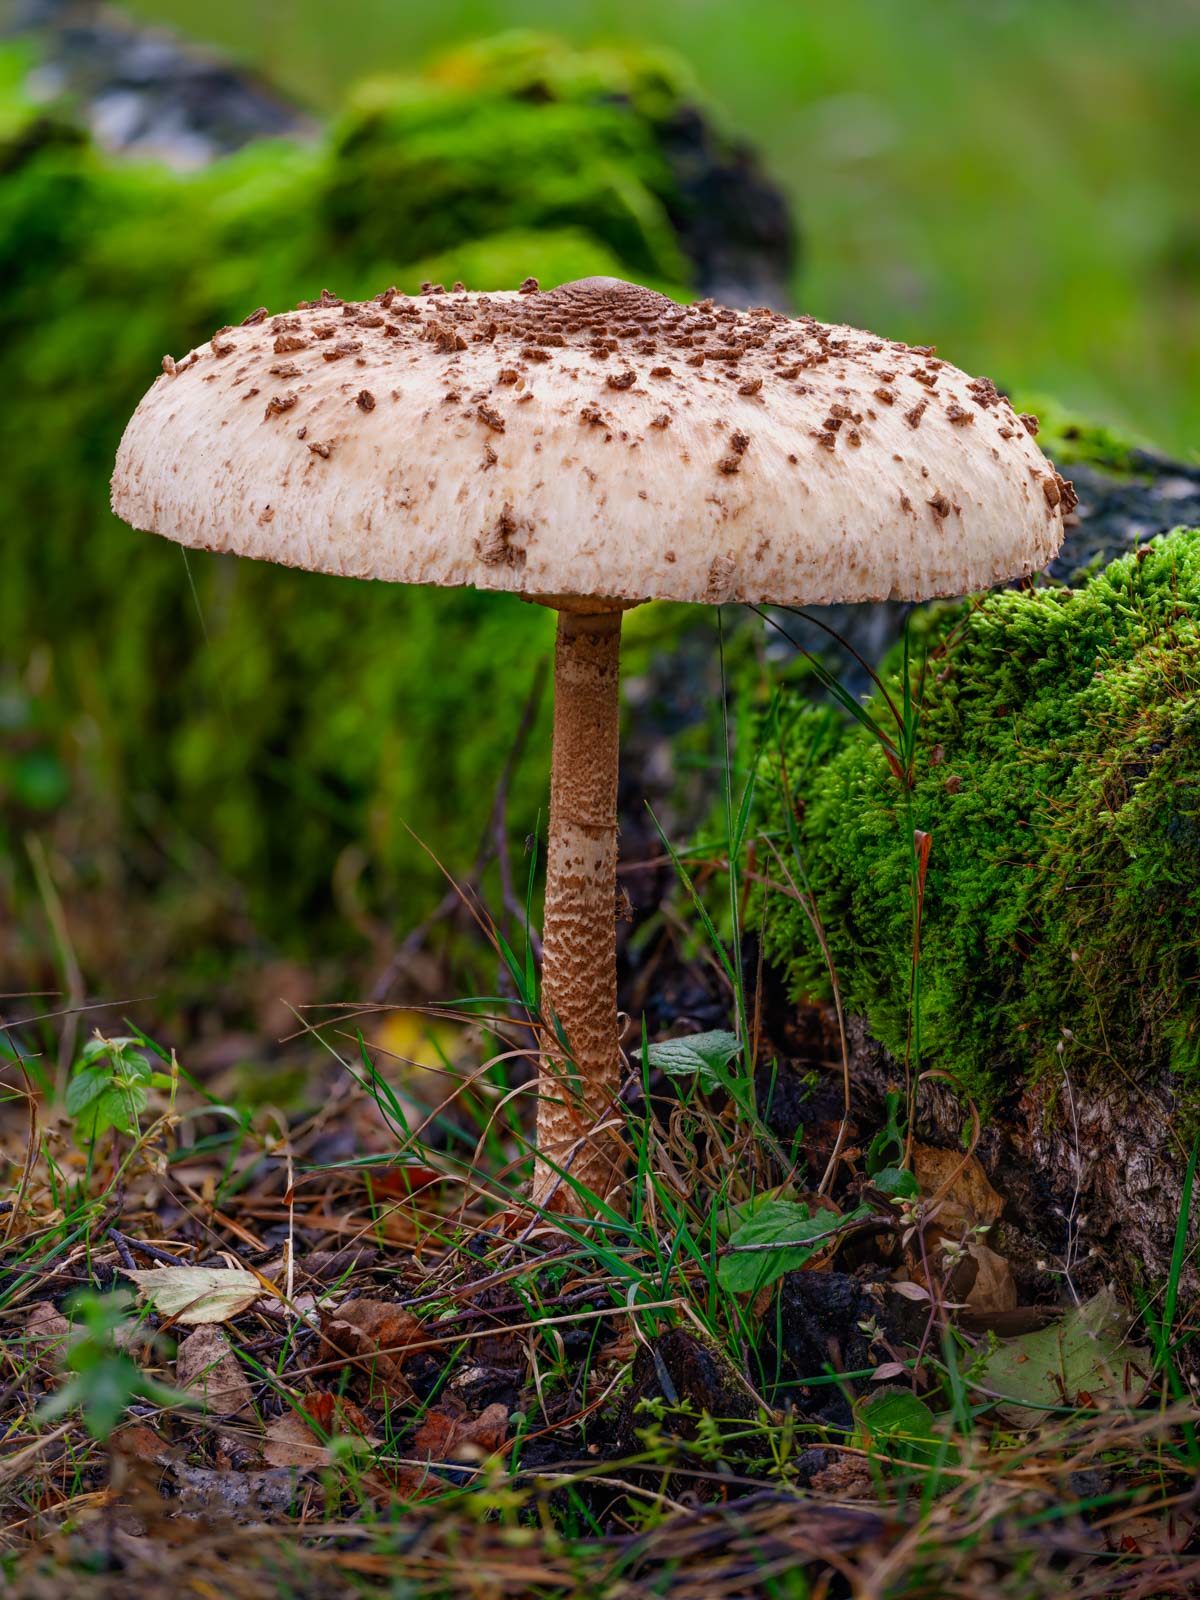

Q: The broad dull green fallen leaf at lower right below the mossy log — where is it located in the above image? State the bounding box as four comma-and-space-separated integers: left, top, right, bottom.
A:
982, 1290, 1152, 1427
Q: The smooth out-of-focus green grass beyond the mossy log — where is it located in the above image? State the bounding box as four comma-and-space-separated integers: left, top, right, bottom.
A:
127, 0, 1200, 453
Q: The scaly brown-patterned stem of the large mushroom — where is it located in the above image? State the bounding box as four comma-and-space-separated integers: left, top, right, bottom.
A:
533, 610, 626, 1211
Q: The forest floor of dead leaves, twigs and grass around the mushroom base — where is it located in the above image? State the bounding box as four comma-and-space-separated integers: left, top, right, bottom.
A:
0, 902, 1200, 1600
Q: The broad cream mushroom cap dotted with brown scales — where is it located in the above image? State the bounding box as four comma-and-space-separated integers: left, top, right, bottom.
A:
112, 278, 1074, 605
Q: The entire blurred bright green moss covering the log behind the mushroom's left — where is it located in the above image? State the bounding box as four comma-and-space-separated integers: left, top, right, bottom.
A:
0, 38, 720, 976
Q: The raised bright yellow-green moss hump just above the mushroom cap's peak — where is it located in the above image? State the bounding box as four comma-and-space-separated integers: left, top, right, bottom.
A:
320, 34, 688, 283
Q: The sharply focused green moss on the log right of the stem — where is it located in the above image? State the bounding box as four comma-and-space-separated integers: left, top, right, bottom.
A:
762, 531, 1200, 1107
